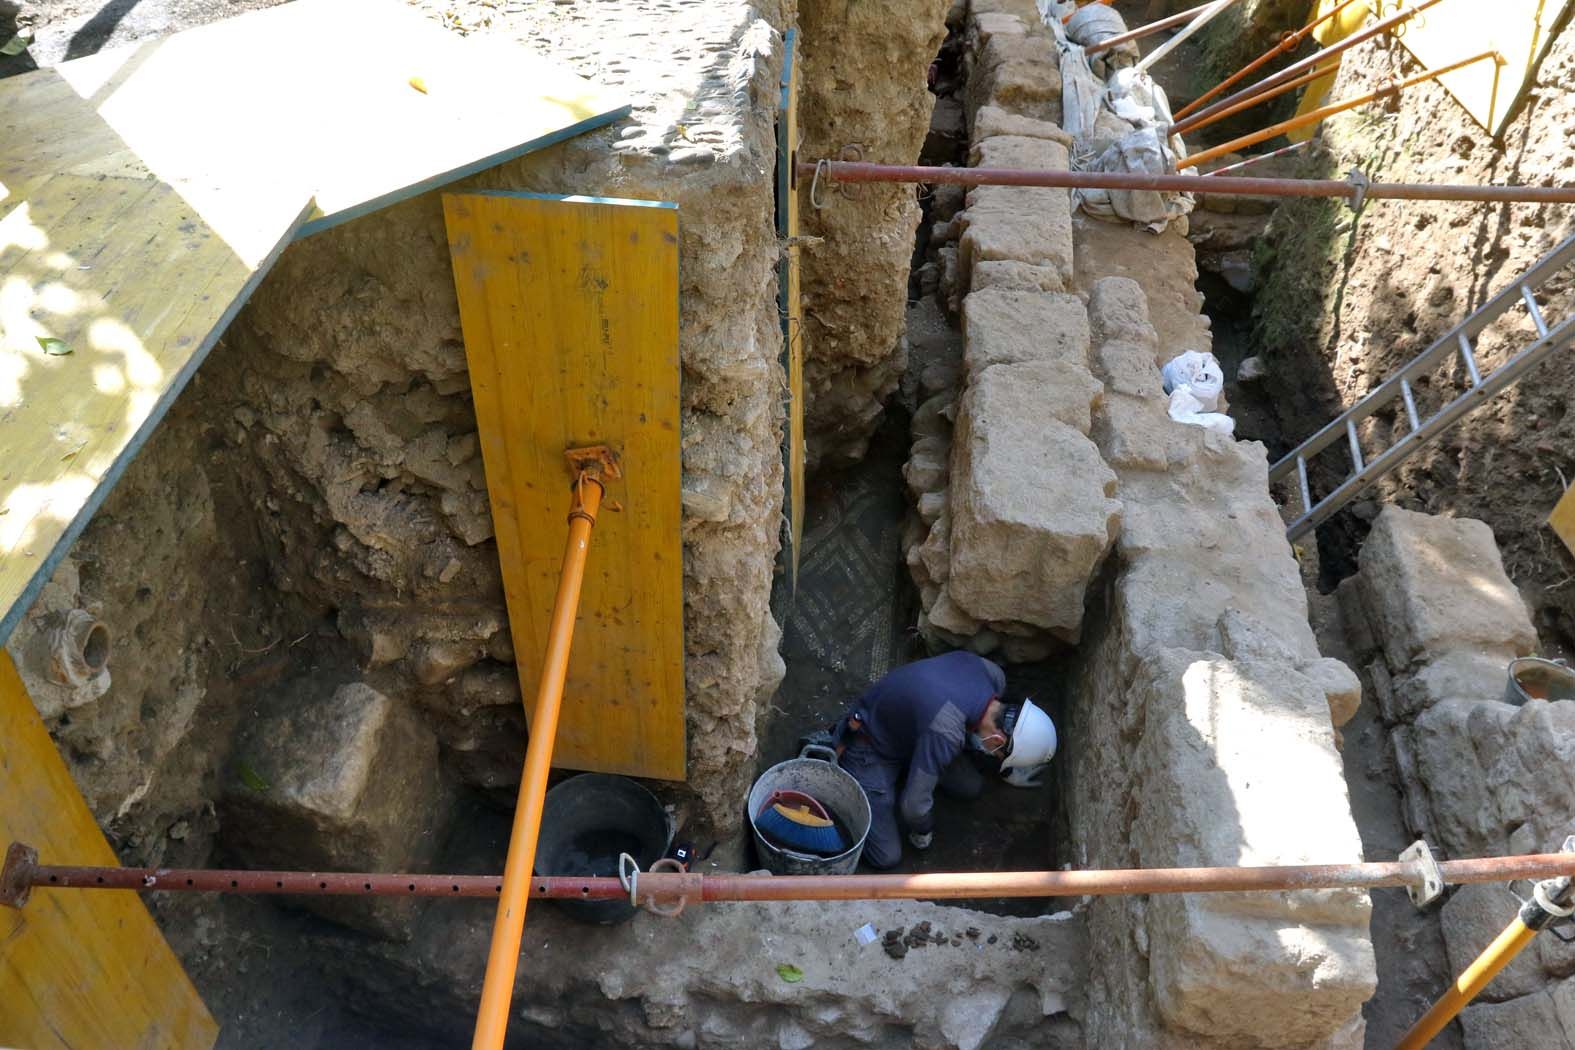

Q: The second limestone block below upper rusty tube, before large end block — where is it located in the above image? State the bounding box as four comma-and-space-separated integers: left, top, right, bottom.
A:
962, 288, 1091, 377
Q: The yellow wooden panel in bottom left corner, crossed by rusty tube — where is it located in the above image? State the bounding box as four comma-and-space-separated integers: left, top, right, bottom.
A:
0, 649, 219, 1050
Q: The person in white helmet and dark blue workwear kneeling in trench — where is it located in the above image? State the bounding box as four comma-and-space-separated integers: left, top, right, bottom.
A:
836, 652, 1055, 867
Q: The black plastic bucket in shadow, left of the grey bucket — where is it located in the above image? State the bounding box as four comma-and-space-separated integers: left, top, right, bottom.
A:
536, 773, 673, 926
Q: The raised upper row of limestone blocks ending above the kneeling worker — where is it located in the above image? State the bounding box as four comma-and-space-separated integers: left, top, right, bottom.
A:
906, 3, 1121, 661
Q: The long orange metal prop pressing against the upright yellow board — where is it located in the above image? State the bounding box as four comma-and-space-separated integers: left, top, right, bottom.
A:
471, 471, 603, 1050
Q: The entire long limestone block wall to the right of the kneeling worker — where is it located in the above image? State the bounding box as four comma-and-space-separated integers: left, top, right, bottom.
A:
907, 0, 1377, 1047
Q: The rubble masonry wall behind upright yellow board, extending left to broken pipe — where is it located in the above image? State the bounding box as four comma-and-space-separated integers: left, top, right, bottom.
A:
11, 0, 794, 867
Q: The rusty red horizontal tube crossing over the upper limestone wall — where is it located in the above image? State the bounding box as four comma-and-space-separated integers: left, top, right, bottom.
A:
799, 161, 1575, 203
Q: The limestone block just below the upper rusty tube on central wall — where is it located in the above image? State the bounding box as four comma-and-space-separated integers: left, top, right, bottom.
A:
958, 186, 1073, 288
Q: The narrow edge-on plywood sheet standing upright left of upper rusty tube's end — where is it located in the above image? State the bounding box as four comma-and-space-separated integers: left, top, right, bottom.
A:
776, 28, 803, 587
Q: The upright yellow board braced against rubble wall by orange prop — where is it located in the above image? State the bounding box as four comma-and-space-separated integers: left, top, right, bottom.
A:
443, 192, 685, 781
